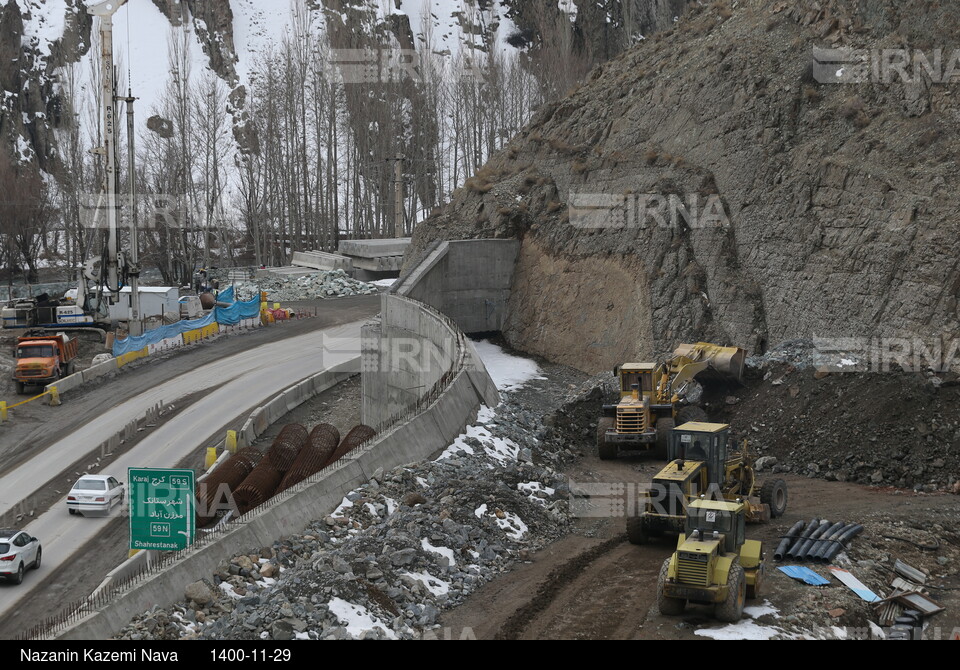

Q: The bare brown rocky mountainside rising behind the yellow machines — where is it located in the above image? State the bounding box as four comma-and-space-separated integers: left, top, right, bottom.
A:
413, 0, 960, 371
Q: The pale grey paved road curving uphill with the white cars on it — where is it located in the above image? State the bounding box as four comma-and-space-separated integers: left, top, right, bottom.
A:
0, 321, 362, 615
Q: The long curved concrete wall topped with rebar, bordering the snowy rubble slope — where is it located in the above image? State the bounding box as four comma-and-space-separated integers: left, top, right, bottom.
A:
49, 296, 499, 640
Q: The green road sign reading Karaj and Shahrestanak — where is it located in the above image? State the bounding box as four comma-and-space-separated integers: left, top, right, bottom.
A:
127, 468, 196, 551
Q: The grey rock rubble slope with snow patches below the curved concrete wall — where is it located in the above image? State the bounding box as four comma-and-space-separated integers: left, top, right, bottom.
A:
117, 392, 573, 640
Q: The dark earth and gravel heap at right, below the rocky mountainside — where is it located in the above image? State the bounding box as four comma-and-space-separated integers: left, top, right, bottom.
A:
706, 363, 960, 492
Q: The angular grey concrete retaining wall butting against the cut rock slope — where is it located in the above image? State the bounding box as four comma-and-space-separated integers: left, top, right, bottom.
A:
391, 240, 520, 333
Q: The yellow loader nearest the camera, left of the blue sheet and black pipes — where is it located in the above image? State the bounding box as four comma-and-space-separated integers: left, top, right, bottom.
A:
657, 499, 765, 623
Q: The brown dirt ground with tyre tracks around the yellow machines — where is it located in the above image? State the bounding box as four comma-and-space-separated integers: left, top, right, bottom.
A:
441, 452, 960, 639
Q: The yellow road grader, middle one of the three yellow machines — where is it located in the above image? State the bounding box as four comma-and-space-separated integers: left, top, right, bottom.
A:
627, 421, 787, 544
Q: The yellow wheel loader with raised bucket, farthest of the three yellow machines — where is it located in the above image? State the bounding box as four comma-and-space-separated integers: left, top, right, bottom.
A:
597, 342, 747, 460
